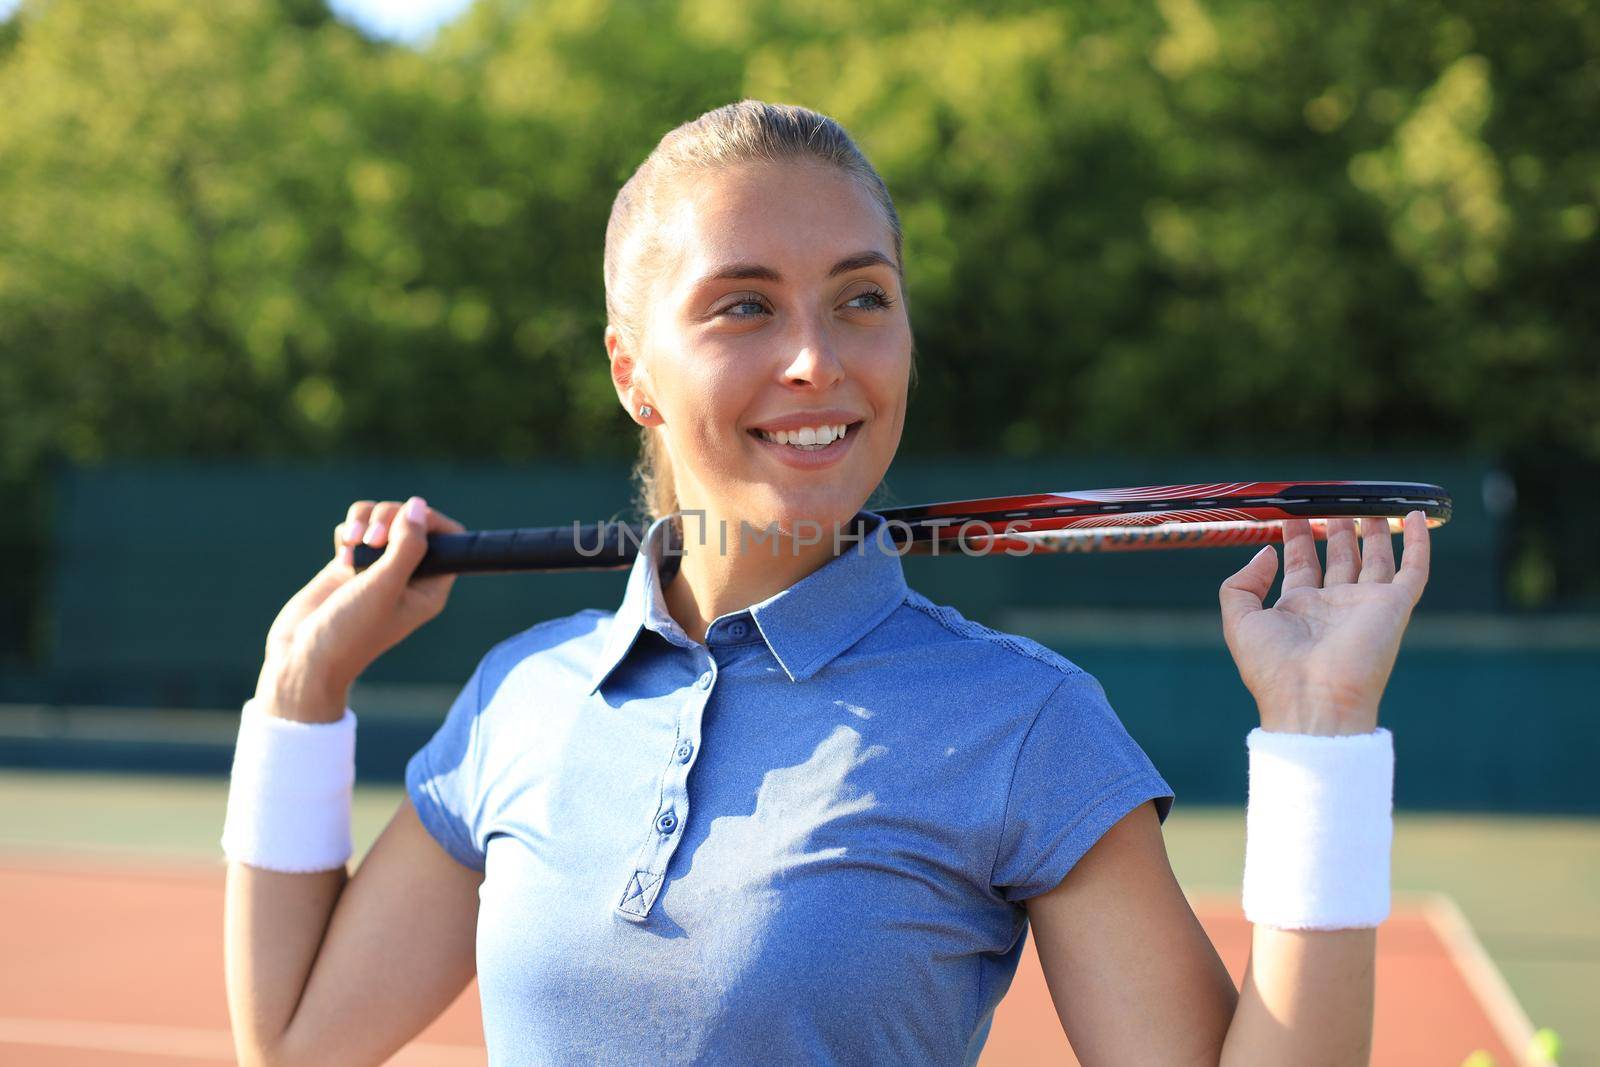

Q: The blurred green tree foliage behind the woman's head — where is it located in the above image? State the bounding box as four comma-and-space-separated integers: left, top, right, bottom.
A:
0, 0, 1600, 659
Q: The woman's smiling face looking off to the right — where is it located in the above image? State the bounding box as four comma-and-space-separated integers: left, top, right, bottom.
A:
606, 163, 912, 547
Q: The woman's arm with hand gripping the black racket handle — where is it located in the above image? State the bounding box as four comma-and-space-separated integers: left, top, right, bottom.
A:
222, 498, 483, 1067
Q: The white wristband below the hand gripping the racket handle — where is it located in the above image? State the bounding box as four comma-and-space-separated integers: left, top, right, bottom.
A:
222, 697, 355, 873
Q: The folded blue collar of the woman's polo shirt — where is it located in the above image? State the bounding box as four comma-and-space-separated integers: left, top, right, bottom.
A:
589, 510, 906, 693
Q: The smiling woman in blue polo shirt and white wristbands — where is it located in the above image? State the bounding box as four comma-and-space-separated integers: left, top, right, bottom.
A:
222, 101, 1427, 1064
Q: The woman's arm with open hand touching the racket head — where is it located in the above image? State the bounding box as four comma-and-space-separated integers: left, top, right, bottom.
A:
1027, 512, 1429, 1065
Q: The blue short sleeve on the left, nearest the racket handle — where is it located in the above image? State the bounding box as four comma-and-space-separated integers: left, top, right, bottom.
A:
405, 656, 488, 870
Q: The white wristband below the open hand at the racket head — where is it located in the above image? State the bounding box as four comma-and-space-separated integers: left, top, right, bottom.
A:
1243, 728, 1395, 929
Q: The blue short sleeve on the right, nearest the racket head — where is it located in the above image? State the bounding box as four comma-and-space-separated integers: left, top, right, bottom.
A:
990, 672, 1173, 902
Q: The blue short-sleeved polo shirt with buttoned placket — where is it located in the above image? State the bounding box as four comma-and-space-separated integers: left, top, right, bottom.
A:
406, 512, 1173, 1067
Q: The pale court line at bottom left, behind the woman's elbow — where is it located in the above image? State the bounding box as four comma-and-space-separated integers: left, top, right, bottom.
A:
0, 1016, 486, 1067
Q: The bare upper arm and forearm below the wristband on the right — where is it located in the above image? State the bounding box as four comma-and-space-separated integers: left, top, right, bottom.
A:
1024, 803, 1374, 1067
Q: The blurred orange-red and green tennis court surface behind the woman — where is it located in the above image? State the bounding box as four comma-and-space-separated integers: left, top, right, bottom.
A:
0, 773, 1600, 1067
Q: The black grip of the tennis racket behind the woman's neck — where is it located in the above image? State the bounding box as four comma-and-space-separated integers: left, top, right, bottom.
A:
352, 523, 643, 577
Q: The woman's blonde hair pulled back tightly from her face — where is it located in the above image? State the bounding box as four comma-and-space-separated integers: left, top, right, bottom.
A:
605, 99, 915, 520
